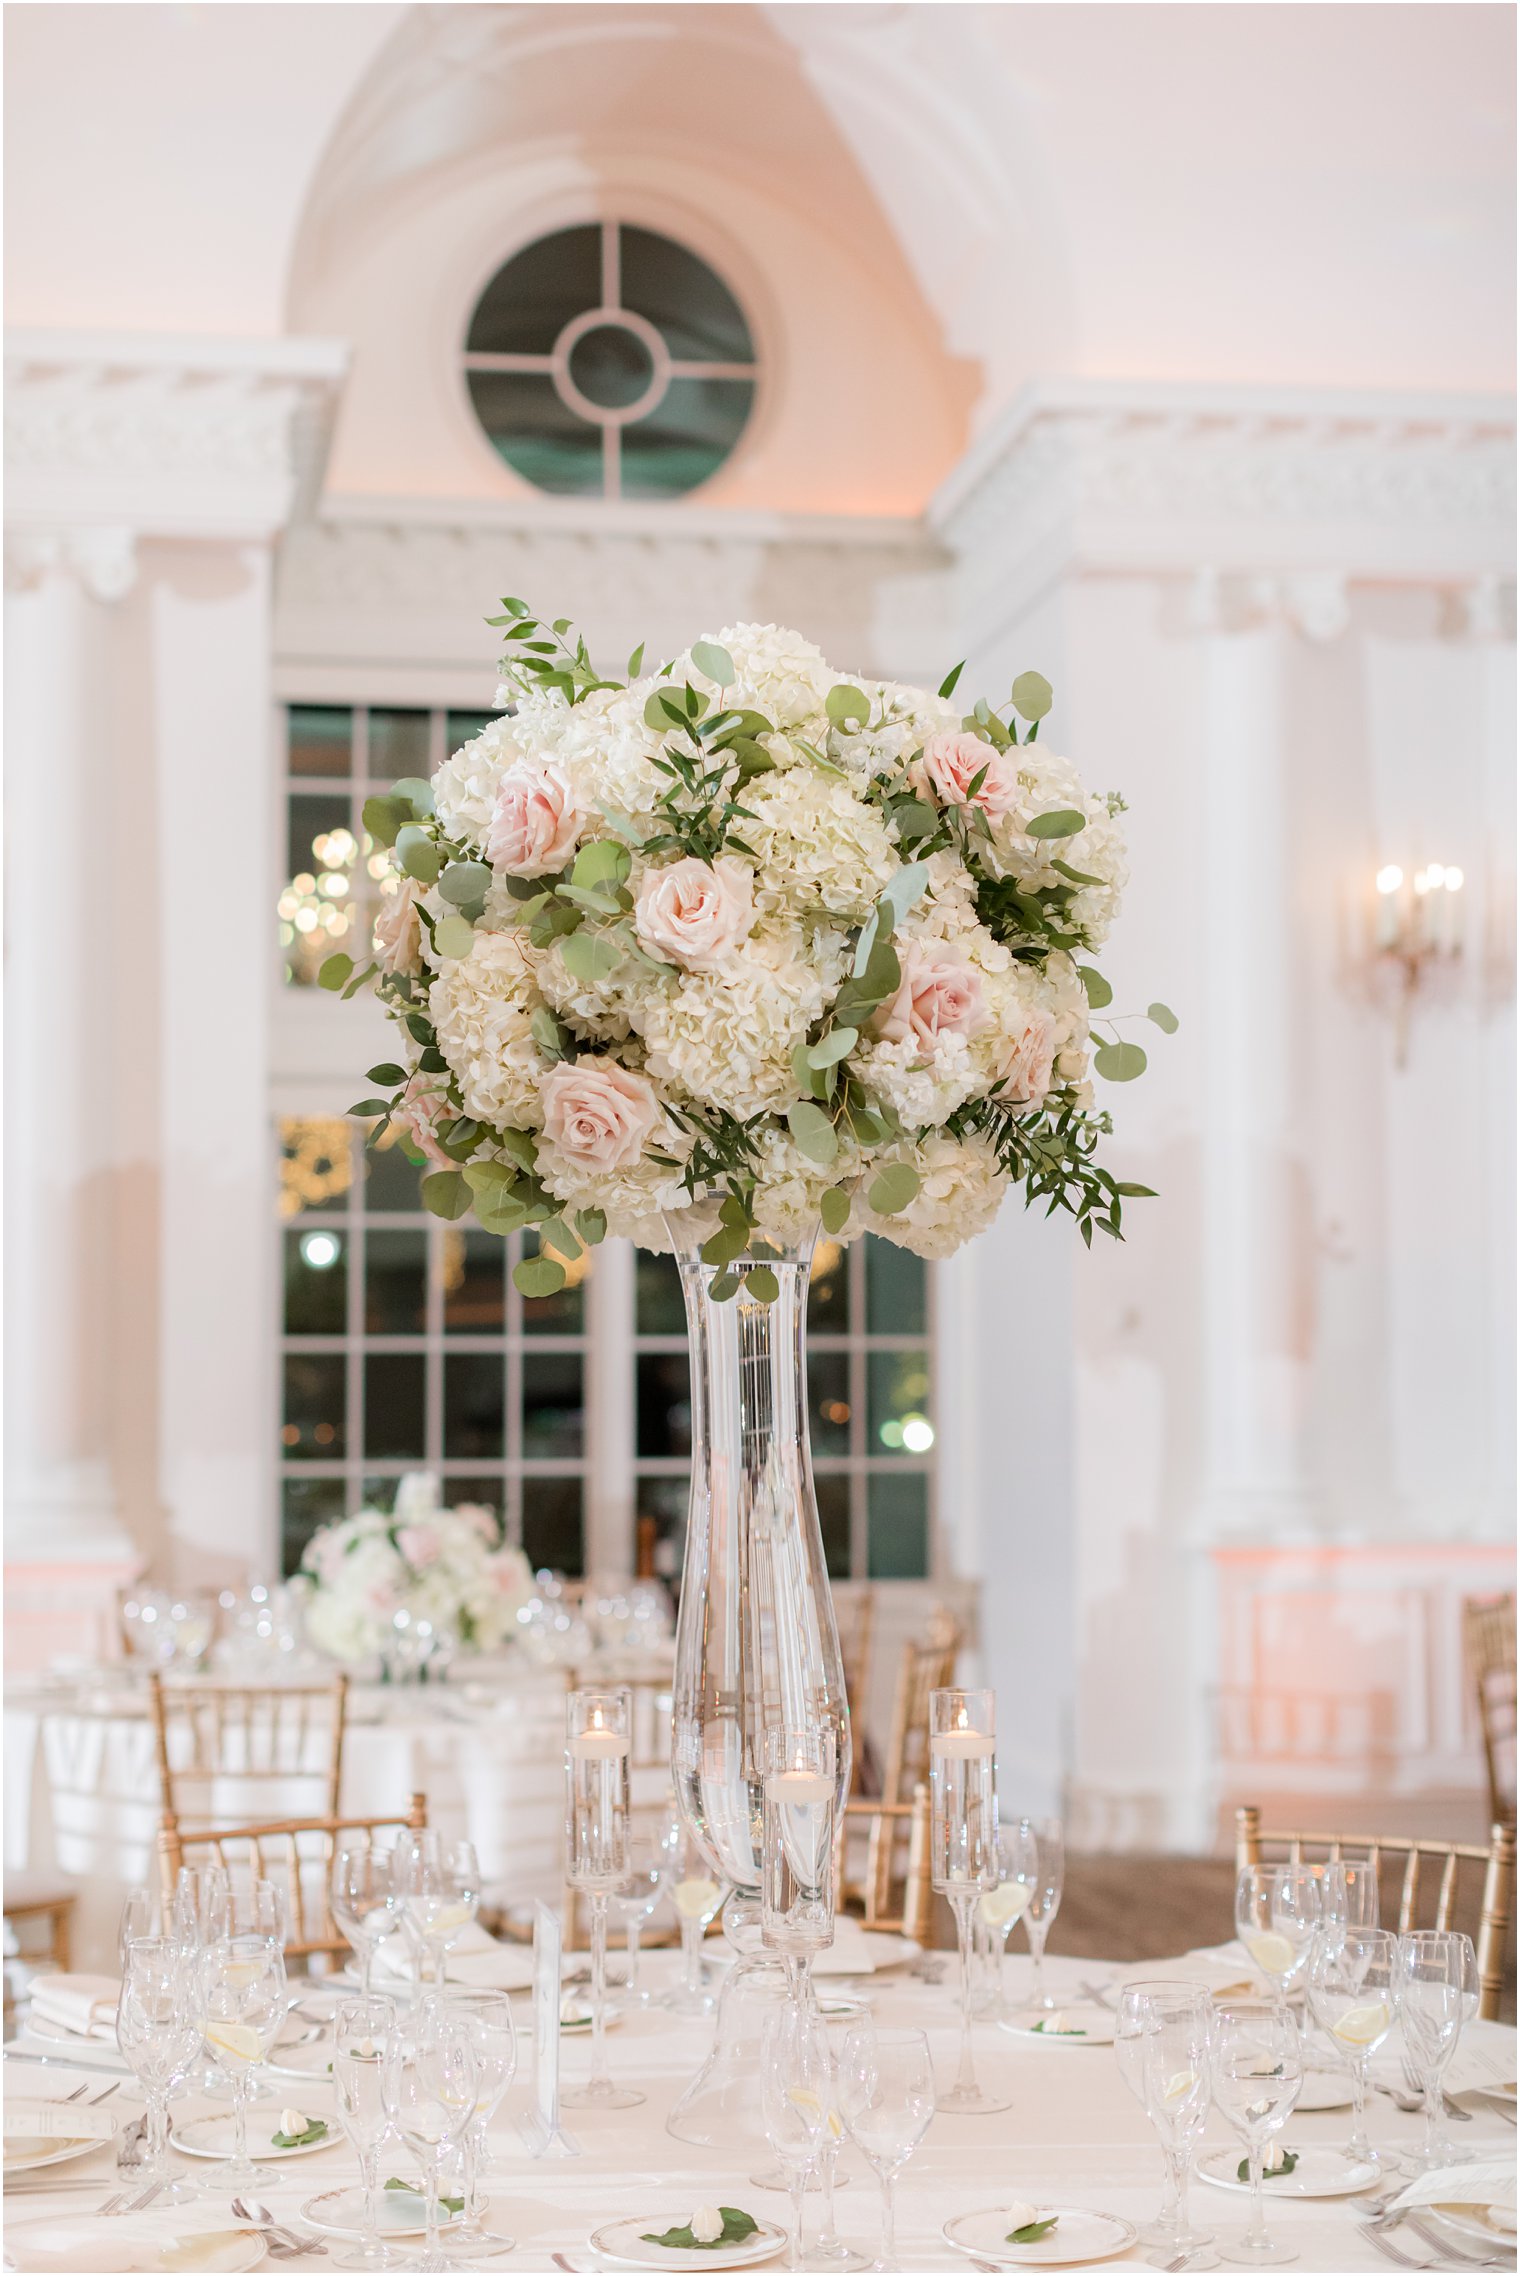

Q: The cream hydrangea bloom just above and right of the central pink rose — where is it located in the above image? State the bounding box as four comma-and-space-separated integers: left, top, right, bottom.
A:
742, 765, 901, 924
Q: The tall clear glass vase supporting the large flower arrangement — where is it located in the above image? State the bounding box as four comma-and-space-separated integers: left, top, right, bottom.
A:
669, 1238, 851, 2142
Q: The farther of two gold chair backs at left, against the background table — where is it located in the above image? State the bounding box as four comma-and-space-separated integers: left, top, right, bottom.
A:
148, 1671, 348, 1819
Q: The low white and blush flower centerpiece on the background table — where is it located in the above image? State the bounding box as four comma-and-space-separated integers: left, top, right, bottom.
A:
300, 1473, 532, 1661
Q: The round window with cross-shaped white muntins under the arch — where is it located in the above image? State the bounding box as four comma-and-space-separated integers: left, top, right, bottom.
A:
464, 221, 755, 498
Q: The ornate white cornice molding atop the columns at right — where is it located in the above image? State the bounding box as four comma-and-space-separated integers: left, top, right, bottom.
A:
928, 380, 1515, 642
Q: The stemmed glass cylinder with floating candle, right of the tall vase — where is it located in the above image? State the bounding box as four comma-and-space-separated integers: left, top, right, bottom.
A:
928, 1684, 1008, 2112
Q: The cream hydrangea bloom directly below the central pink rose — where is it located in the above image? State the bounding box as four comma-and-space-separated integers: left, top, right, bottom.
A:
639, 926, 837, 1120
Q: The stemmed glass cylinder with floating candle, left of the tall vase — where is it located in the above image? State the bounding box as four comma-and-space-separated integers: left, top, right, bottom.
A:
560, 1684, 644, 2110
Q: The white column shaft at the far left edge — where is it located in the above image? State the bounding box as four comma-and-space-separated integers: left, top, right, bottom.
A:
5, 560, 137, 1659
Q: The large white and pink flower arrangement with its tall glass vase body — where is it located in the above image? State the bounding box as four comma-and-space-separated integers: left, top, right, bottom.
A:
321, 601, 1176, 1898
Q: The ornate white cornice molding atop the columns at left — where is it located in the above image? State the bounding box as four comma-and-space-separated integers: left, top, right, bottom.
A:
5, 332, 348, 573
